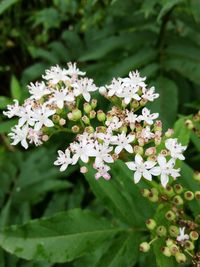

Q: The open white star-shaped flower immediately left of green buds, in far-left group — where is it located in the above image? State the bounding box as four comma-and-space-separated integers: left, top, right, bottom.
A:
33, 105, 56, 131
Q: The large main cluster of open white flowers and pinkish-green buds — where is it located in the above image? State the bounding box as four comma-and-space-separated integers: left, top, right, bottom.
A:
4, 63, 186, 187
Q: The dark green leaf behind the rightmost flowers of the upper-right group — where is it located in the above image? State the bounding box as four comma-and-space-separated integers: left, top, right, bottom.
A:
148, 76, 178, 129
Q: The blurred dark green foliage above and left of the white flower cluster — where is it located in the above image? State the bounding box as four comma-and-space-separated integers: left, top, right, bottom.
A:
0, 0, 200, 267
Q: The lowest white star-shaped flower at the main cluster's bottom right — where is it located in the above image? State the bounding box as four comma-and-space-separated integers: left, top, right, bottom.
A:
151, 155, 180, 187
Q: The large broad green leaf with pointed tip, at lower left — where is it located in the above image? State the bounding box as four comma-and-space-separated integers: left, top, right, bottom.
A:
0, 209, 119, 262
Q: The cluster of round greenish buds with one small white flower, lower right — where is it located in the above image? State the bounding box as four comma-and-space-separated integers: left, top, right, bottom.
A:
140, 182, 200, 266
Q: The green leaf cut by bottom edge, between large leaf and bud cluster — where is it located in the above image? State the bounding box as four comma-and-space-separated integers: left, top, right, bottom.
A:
95, 231, 141, 267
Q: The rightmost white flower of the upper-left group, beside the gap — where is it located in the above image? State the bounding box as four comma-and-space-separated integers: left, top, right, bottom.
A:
73, 78, 98, 102
